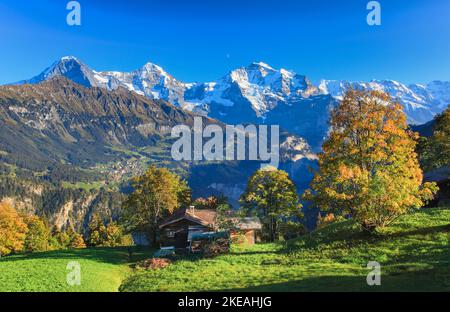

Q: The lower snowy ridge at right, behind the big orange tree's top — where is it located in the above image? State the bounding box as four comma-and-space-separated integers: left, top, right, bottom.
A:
319, 80, 450, 124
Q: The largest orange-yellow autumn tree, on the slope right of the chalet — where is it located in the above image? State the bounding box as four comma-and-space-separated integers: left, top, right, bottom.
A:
305, 90, 436, 231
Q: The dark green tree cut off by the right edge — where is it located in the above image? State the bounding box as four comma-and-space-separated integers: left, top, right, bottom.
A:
418, 106, 450, 171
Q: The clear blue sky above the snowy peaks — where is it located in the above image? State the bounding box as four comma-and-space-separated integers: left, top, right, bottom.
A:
0, 0, 450, 84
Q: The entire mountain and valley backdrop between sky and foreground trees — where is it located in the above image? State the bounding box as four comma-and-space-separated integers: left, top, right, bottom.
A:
0, 57, 450, 230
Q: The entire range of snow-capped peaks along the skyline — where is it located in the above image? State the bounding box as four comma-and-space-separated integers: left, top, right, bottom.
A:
15, 56, 450, 129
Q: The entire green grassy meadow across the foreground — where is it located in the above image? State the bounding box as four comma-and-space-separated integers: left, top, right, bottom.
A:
0, 208, 450, 291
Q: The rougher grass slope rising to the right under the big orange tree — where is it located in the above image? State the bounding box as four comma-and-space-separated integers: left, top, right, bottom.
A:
120, 209, 450, 291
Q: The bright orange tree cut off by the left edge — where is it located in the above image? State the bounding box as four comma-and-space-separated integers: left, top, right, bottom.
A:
0, 202, 28, 256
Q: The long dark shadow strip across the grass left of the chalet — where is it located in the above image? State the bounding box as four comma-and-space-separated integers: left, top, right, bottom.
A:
0, 247, 154, 264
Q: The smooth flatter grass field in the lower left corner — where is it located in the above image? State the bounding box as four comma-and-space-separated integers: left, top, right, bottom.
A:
0, 248, 151, 292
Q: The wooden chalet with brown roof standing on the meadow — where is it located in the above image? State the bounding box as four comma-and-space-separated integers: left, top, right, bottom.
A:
159, 206, 261, 248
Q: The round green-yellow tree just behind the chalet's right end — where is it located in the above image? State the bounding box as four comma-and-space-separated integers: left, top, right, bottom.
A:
240, 168, 301, 242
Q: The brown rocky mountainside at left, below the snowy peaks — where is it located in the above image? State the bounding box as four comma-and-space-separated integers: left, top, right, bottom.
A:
0, 77, 193, 171
